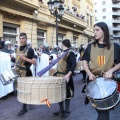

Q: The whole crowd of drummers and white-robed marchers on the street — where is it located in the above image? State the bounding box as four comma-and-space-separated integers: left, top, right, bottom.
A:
0, 22, 120, 120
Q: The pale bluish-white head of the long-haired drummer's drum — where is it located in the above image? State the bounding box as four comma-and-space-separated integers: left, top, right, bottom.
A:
86, 77, 117, 99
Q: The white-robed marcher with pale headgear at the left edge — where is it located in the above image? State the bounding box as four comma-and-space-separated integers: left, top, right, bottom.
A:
0, 41, 13, 99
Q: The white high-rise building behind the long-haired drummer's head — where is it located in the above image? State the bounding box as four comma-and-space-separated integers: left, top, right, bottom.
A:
94, 0, 120, 44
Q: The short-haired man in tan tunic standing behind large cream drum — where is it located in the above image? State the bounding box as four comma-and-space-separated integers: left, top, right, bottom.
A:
16, 33, 36, 116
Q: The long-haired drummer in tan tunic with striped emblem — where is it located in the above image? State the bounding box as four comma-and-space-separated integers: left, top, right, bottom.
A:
82, 22, 120, 120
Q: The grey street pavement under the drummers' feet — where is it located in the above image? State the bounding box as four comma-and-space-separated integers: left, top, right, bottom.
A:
0, 75, 120, 120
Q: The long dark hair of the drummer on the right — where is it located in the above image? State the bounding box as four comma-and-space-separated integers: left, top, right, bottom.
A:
93, 22, 110, 50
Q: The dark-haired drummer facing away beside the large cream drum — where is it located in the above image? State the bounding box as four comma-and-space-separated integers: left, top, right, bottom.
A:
53, 39, 76, 118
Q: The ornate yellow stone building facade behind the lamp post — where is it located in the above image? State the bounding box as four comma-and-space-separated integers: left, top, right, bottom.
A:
0, 0, 94, 48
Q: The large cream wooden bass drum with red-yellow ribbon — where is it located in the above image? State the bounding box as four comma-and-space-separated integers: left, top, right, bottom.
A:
17, 76, 66, 104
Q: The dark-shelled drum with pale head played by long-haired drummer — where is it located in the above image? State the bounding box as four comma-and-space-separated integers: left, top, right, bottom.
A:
86, 77, 119, 110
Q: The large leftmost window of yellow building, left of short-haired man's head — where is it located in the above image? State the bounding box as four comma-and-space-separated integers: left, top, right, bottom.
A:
3, 23, 19, 47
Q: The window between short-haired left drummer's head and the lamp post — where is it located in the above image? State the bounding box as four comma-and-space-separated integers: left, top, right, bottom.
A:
37, 30, 46, 47
